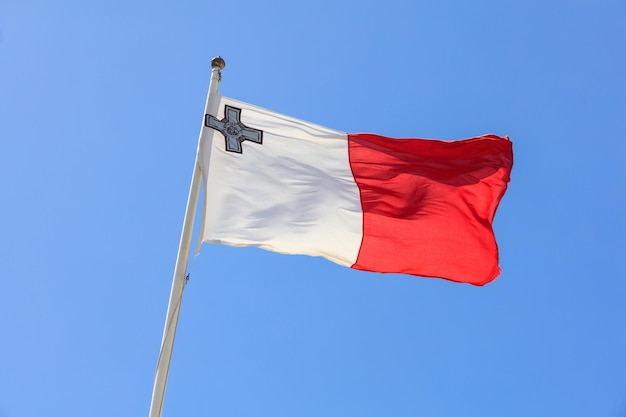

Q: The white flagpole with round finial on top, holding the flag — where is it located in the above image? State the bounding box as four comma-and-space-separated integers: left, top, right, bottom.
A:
150, 56, 226, 417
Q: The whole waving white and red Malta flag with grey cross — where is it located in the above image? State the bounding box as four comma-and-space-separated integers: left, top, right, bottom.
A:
198, 96, 513, 285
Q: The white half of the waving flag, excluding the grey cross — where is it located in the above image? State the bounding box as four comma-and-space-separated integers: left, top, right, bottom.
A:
199, 96, 363, 266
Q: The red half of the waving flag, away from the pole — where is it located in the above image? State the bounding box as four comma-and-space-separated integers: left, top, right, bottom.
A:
348, 134, 513, 285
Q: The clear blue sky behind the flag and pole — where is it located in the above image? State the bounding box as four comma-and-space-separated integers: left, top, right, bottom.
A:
0, 0, 626, 417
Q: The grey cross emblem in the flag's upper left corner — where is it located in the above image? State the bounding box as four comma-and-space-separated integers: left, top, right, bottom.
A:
204, 105, 263, 153
